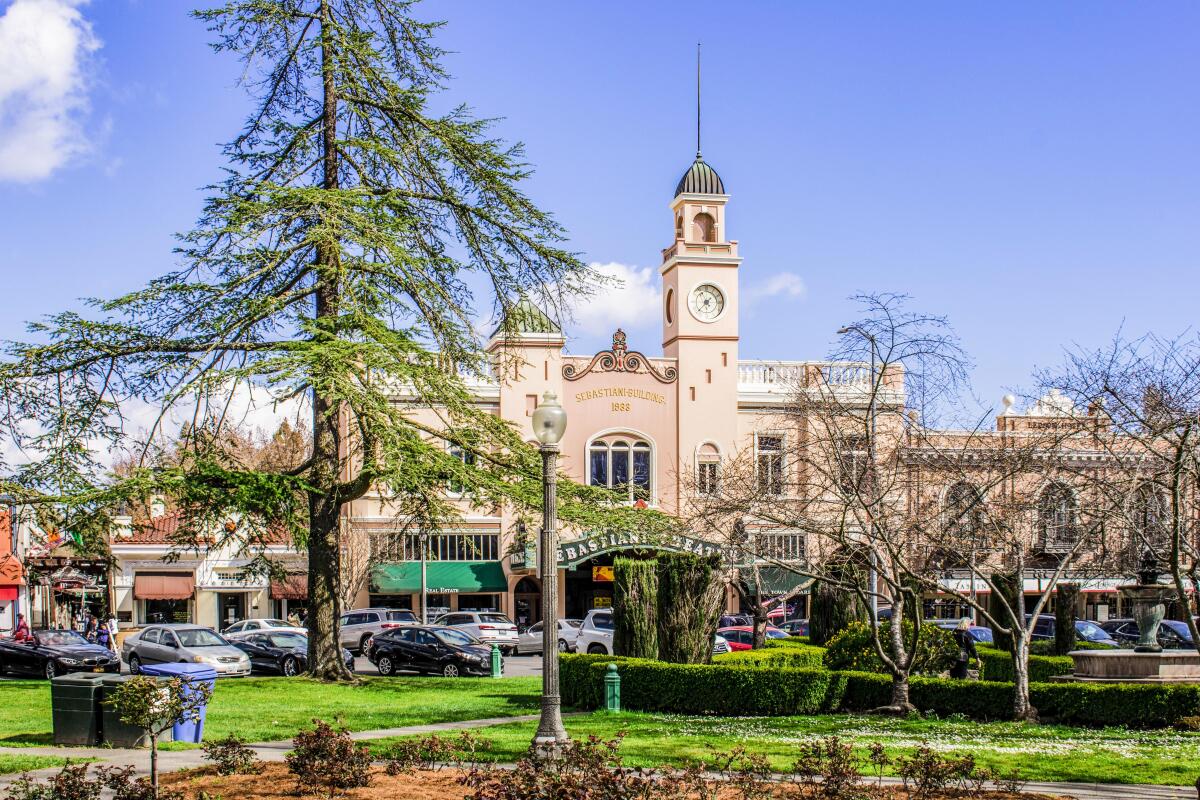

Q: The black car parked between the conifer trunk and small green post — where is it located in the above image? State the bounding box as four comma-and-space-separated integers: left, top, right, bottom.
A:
367, 625, 492, 678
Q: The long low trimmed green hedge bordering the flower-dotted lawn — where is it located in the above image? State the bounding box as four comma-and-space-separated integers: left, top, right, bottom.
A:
560, 651, 1200, 728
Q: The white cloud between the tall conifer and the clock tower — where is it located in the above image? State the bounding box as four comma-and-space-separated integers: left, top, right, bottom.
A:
571, 261, 662, 336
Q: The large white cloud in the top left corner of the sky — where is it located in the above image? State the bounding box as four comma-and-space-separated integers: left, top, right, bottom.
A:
0, 0, 100, 182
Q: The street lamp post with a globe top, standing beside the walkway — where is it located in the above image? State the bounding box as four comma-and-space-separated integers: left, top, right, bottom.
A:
533, 391, 569, 759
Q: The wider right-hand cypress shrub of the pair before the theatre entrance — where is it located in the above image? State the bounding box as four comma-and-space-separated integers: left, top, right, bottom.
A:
655, 553, 725, 664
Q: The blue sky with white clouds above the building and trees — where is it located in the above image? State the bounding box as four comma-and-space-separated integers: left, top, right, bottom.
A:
0, 0, 1200, 419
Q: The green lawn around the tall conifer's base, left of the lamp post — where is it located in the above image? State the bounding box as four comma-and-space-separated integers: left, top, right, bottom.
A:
0, 678, 541, 747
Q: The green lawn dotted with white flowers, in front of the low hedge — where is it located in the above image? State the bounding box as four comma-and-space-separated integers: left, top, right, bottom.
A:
370, 712, 1200, 786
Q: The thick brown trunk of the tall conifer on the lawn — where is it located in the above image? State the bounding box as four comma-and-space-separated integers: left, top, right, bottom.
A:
307, 0, 353, 680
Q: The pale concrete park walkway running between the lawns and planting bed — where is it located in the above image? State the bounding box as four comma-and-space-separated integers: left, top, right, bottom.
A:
0, 714, 1198, 800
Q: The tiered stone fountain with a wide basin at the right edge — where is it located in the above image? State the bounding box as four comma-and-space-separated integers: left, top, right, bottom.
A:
1069, 553, 1200, 684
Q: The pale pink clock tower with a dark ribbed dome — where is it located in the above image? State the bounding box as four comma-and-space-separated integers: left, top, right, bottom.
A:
659, 150, 742, 507
